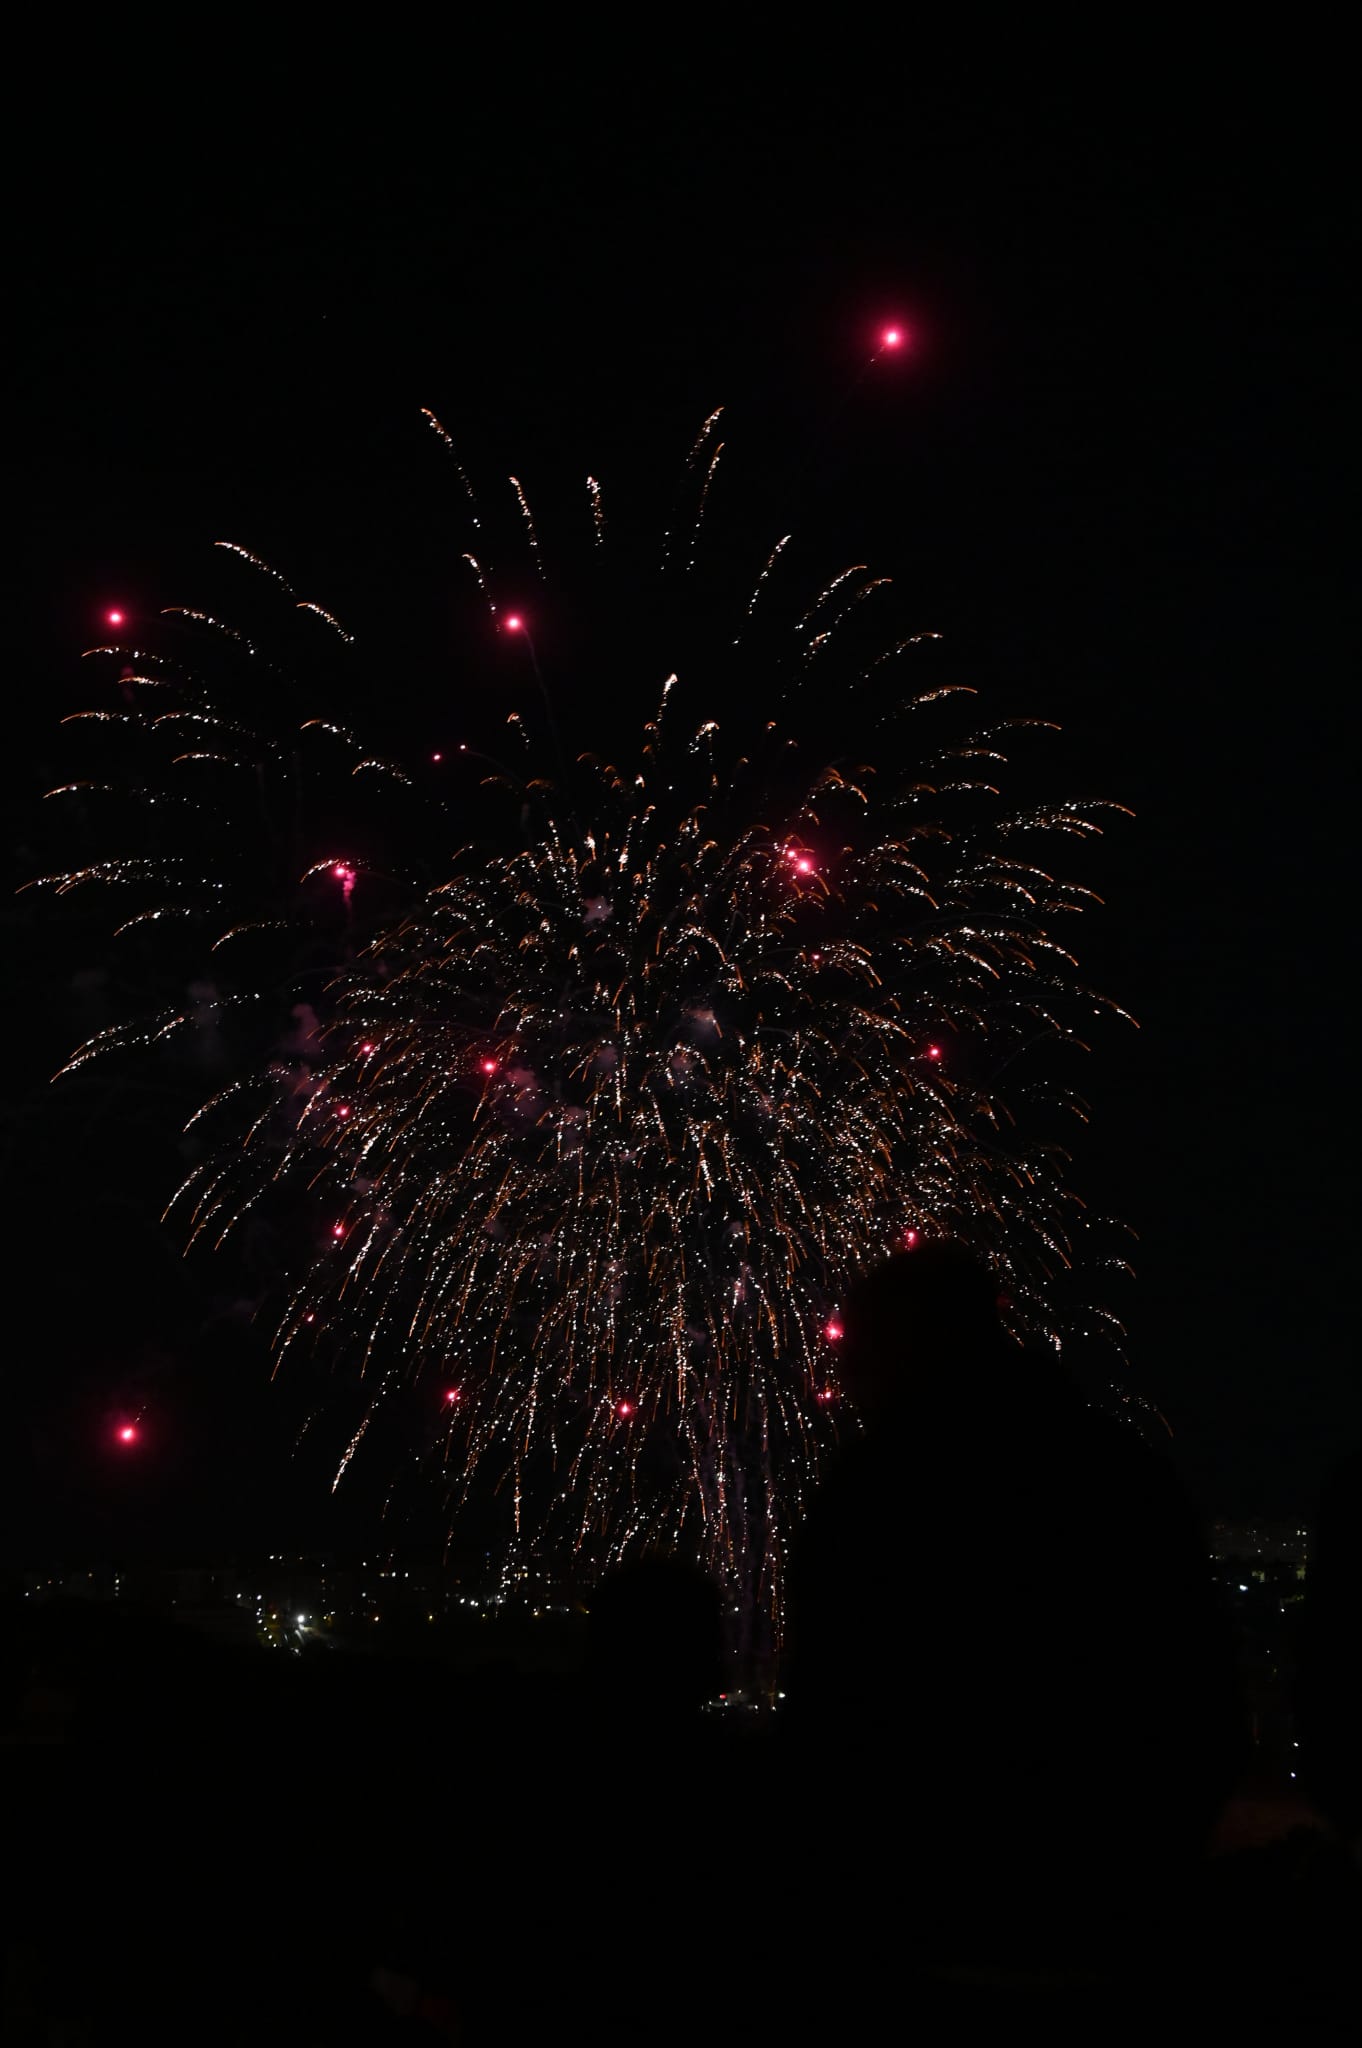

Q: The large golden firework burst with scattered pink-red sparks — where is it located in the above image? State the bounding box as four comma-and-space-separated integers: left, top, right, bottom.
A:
43, 407, 1112, 1618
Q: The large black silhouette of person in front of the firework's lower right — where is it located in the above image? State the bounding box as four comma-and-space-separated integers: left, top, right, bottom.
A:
786, 1241, 1237, 1974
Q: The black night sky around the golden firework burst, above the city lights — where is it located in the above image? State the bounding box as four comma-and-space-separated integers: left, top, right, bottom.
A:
6, 68, 1362, 1552
